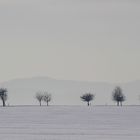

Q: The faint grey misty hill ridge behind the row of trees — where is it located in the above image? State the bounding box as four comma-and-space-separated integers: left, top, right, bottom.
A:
0, 77, 140, 105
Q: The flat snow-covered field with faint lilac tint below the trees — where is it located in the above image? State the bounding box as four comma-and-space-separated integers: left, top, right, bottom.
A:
0, 106, 140, 140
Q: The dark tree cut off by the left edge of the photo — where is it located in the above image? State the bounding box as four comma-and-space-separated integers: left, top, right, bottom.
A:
0, 88, 8, 106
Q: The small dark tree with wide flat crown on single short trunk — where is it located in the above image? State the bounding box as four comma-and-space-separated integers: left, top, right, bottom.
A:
80, 93, 95, 106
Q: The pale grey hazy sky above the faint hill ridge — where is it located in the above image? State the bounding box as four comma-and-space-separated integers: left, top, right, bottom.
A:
0, 0, 140, 82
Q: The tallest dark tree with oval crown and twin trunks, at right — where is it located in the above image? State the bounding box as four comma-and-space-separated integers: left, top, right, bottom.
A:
112, 86, 125, 106
